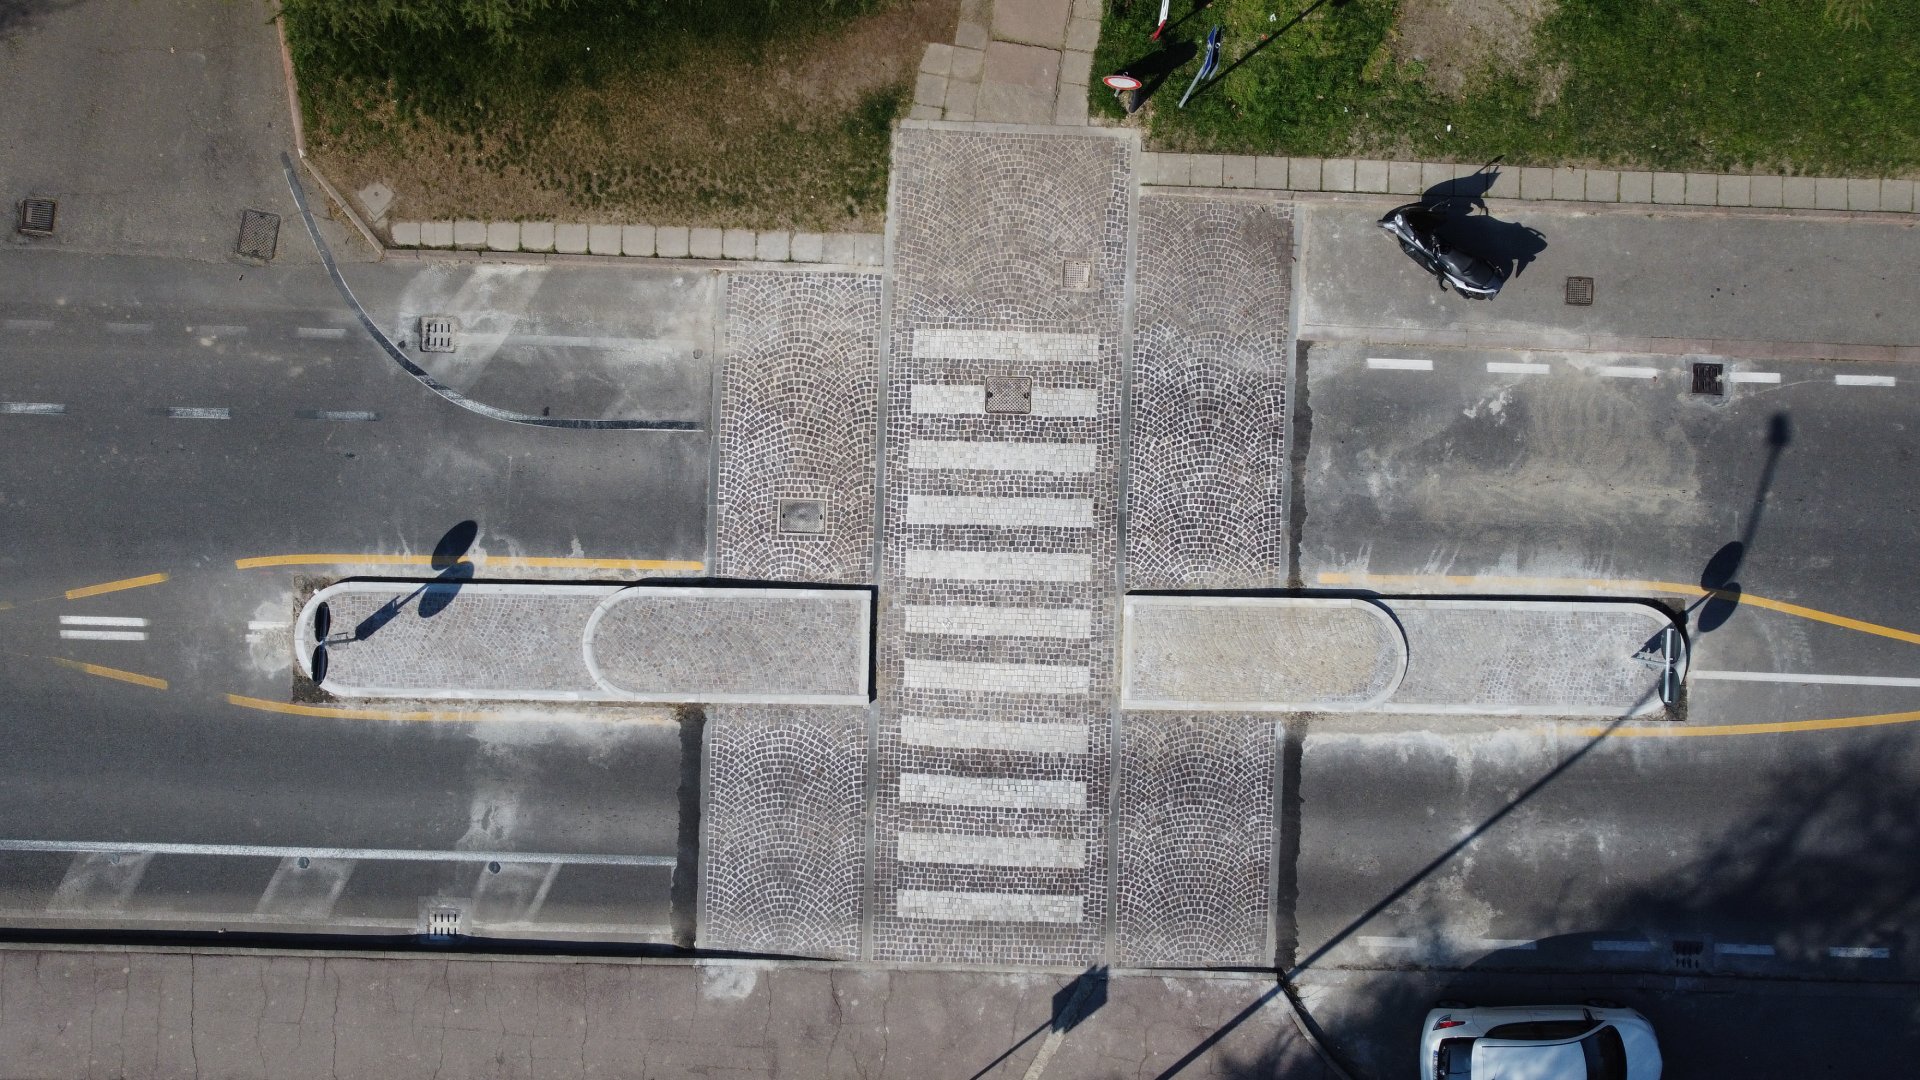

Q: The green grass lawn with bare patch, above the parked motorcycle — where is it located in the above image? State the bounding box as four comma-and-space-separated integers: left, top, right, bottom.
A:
1092, 0, 1920, 177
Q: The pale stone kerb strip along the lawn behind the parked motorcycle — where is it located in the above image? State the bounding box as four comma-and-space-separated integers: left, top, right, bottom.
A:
1140, 154, 1920, 213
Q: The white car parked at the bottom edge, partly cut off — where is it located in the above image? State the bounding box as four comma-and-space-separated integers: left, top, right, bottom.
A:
1421, 1005, 1661, 1080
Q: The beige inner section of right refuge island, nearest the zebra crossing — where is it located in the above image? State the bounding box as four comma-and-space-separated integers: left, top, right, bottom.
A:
1121, 596, 1407, 713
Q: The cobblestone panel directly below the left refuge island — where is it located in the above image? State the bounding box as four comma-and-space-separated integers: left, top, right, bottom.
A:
699, 705, 868, 959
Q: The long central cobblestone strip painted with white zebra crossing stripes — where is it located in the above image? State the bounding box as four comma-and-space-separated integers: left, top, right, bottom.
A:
872, 125, 1133, 963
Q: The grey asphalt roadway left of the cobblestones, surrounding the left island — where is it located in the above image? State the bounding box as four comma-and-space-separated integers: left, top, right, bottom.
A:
0, 252, 710, 938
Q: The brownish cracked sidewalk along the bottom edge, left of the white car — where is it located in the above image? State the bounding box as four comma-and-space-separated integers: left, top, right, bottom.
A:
0, 945, 1336, 1080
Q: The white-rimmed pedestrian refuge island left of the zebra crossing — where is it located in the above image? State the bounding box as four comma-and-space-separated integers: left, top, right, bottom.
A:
294, 580, 874, 705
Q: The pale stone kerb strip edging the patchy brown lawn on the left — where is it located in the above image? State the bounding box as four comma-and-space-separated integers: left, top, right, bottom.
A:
388, 221, 885, 267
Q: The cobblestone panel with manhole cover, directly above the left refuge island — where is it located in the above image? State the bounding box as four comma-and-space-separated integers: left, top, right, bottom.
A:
714, 273, 881, 582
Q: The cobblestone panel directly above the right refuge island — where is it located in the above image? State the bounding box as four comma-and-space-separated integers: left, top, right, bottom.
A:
1127, 196, 1292, 588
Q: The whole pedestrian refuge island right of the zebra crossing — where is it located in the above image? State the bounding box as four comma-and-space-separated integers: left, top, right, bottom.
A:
1121, 594, 1686, 717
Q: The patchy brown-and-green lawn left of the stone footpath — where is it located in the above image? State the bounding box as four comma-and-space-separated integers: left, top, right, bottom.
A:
288, 0, 958, 231
